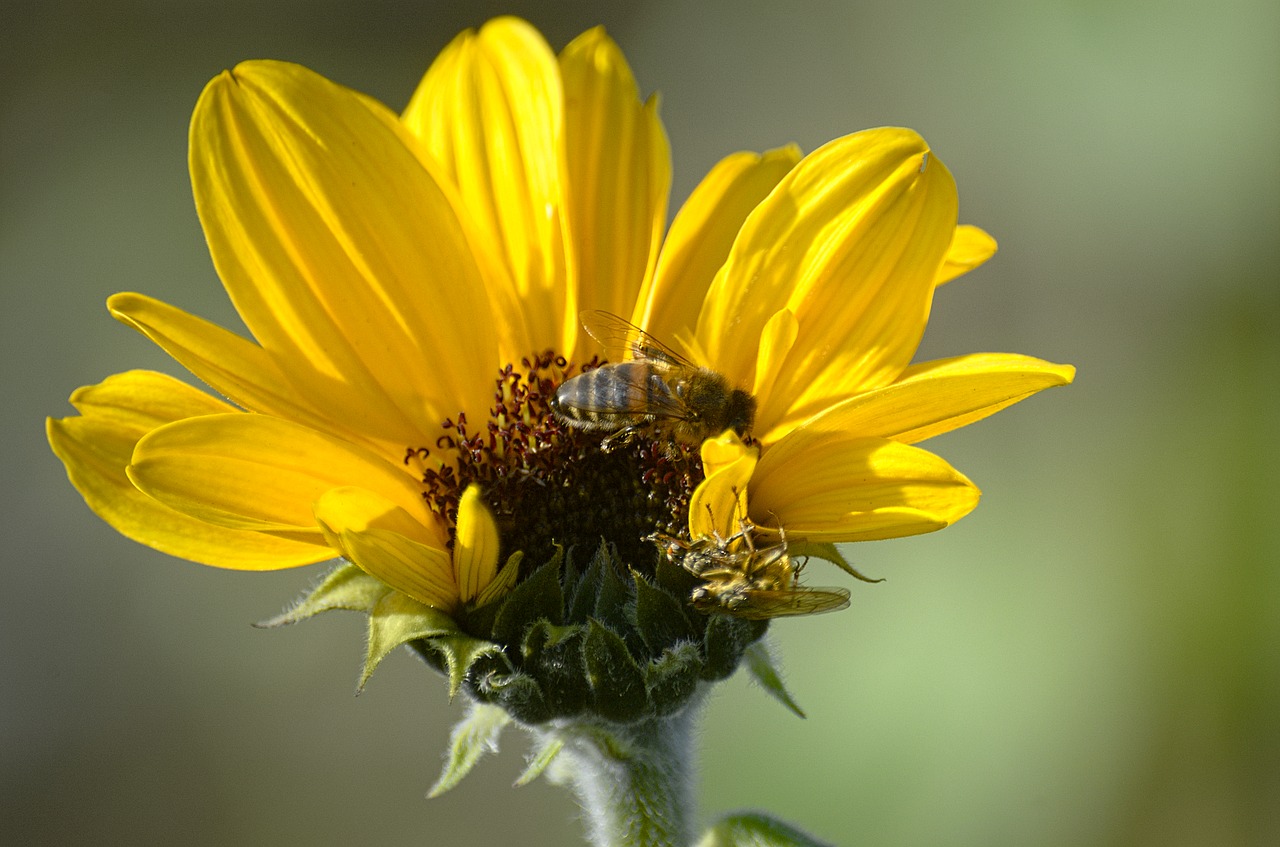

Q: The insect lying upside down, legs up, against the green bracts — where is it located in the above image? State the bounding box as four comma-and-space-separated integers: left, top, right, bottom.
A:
650, 518, 849, 621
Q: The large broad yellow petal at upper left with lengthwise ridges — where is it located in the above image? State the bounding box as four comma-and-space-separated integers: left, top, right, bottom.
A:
191, 61, 498, 445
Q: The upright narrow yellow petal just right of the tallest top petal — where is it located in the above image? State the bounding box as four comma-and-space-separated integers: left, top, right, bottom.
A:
561, 27, 671, 355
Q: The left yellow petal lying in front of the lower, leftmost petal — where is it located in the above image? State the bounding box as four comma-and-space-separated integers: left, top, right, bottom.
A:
128, 415, 434, 542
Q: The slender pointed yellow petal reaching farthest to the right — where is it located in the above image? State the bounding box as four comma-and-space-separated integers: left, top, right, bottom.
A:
760, 353, 1075, 444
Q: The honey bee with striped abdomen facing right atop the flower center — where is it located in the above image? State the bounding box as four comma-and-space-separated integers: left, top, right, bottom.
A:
550, 311, 755, 450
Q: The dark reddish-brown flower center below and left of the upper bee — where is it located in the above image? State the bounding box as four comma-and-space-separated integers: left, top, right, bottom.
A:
406, 351, 703, 577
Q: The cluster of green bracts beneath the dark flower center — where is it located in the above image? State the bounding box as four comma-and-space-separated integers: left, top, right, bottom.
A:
273, 544, 762, 725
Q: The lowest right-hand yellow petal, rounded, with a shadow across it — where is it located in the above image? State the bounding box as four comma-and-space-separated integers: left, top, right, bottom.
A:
750, 427, 979, 541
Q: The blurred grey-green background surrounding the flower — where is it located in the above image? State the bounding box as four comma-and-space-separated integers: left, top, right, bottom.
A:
0, 0, 1280, 847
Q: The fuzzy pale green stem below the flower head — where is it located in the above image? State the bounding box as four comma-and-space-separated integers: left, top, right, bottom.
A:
540, 699, 700, 847
